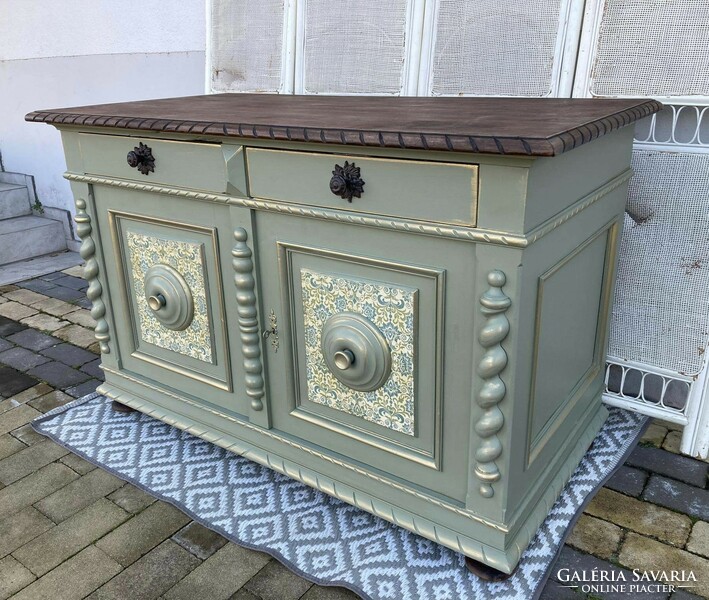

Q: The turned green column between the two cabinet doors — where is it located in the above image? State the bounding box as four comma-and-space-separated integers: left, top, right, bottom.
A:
231, 227, 265, 411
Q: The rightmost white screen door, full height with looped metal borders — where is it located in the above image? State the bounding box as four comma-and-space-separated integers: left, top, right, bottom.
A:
573, 0, 709, 457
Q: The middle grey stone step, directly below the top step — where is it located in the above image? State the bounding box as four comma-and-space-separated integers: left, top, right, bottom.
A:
0, 216, 66, 265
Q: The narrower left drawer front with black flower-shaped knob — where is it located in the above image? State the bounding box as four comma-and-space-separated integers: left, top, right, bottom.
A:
79, 133, 246, 195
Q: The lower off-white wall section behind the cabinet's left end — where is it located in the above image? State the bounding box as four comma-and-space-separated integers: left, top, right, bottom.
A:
0, 52, 204, 213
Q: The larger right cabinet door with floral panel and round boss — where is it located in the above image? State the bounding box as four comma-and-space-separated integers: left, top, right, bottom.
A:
257, 213, 474, 501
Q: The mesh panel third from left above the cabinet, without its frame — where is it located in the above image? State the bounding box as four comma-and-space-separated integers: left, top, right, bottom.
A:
431, 0, 561, 96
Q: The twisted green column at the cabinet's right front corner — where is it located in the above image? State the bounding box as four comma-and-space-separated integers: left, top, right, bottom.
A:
475, 270, 512, 498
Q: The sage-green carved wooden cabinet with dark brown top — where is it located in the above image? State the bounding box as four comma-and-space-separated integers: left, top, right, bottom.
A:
28, 95, 660, 572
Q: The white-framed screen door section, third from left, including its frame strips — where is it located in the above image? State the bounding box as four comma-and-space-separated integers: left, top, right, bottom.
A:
418, 0, 583, 97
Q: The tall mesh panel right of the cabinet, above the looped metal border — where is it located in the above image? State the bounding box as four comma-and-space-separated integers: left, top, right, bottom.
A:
609, 150, 709, 374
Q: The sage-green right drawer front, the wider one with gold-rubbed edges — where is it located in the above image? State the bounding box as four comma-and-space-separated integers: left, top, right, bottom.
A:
247, 148, 478, 227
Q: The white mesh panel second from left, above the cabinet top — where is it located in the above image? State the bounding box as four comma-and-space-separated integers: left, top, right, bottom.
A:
303, 0, 408, 94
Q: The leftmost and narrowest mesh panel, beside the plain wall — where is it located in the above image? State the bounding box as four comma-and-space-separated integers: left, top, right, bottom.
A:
210, 0, 285, 92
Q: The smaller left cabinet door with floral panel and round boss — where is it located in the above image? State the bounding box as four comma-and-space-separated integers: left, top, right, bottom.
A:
94, 186, 248, 414
